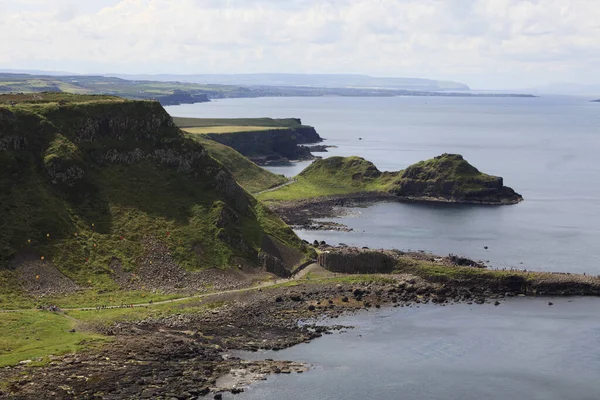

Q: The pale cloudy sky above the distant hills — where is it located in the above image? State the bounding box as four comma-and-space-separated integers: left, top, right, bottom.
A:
0, 0, 600, 89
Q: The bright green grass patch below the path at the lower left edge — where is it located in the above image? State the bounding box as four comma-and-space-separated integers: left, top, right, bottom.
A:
0, 311, 108, 367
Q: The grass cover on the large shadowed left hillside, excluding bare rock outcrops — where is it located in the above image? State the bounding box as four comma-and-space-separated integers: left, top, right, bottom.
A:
0, 96, 301, 308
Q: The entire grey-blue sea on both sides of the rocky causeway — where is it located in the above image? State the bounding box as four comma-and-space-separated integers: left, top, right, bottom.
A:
167, 96, 600, 400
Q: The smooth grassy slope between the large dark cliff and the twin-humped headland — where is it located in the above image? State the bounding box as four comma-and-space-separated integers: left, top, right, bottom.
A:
190, 135, 288, 193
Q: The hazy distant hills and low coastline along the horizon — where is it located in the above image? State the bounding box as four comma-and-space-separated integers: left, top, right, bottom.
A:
0, 70, 534, 105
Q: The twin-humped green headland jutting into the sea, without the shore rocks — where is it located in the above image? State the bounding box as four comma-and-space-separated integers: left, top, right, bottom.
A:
260, 154, 523, 204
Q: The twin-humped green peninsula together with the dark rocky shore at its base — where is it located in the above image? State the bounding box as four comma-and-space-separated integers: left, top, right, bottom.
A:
258, 154, 523, 230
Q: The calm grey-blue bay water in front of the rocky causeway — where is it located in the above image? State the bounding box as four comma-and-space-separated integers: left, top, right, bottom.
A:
231, 298, 600, 400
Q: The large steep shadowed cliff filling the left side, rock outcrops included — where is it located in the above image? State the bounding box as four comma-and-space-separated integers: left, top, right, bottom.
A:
0, 93, 304, 291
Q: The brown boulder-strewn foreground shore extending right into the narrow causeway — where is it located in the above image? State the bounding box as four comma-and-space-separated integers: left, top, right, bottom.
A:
0, 252, 600, 400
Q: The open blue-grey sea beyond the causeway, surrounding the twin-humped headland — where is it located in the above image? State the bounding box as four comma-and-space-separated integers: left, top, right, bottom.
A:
167, 96, 600, 274
